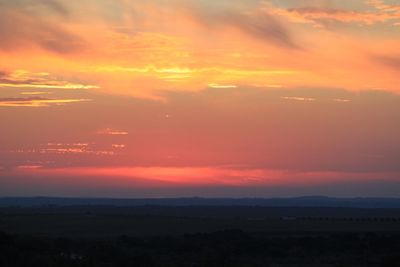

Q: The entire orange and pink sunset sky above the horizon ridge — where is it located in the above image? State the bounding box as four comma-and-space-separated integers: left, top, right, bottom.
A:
0, 0, 400, 197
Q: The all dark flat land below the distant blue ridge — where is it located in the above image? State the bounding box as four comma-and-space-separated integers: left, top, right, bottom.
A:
0, 205, 400, 267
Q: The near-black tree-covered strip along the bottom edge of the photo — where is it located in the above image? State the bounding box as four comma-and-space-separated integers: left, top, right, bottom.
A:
0, 230, 400, 267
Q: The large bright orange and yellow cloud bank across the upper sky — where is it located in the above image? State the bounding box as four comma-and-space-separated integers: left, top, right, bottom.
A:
0, 1, 398, 98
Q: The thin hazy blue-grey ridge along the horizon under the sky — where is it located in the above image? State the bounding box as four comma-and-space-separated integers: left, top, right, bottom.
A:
0, 196, 400, 209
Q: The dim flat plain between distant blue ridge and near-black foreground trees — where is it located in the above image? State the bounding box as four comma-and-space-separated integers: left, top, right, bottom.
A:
0, 206, 400, 238
